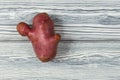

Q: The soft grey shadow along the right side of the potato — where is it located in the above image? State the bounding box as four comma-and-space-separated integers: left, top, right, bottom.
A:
50, 15, 73, 62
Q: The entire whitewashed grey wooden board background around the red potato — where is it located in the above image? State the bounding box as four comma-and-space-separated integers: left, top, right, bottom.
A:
0, 0, 120, 80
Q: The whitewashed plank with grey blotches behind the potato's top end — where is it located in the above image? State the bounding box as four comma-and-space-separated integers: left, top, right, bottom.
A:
0, 3, 120, 26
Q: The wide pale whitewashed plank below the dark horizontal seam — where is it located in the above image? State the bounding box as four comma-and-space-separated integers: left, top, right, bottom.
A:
0, 41, 120, 80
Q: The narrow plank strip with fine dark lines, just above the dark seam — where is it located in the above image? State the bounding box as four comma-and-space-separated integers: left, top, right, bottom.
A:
0, 25, 120, 41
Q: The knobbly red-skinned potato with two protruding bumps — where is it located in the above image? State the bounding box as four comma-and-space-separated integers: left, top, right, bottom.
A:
17, 13, 61, 62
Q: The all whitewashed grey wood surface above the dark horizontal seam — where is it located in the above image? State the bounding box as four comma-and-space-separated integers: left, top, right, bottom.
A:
0, 0, 120, 40
